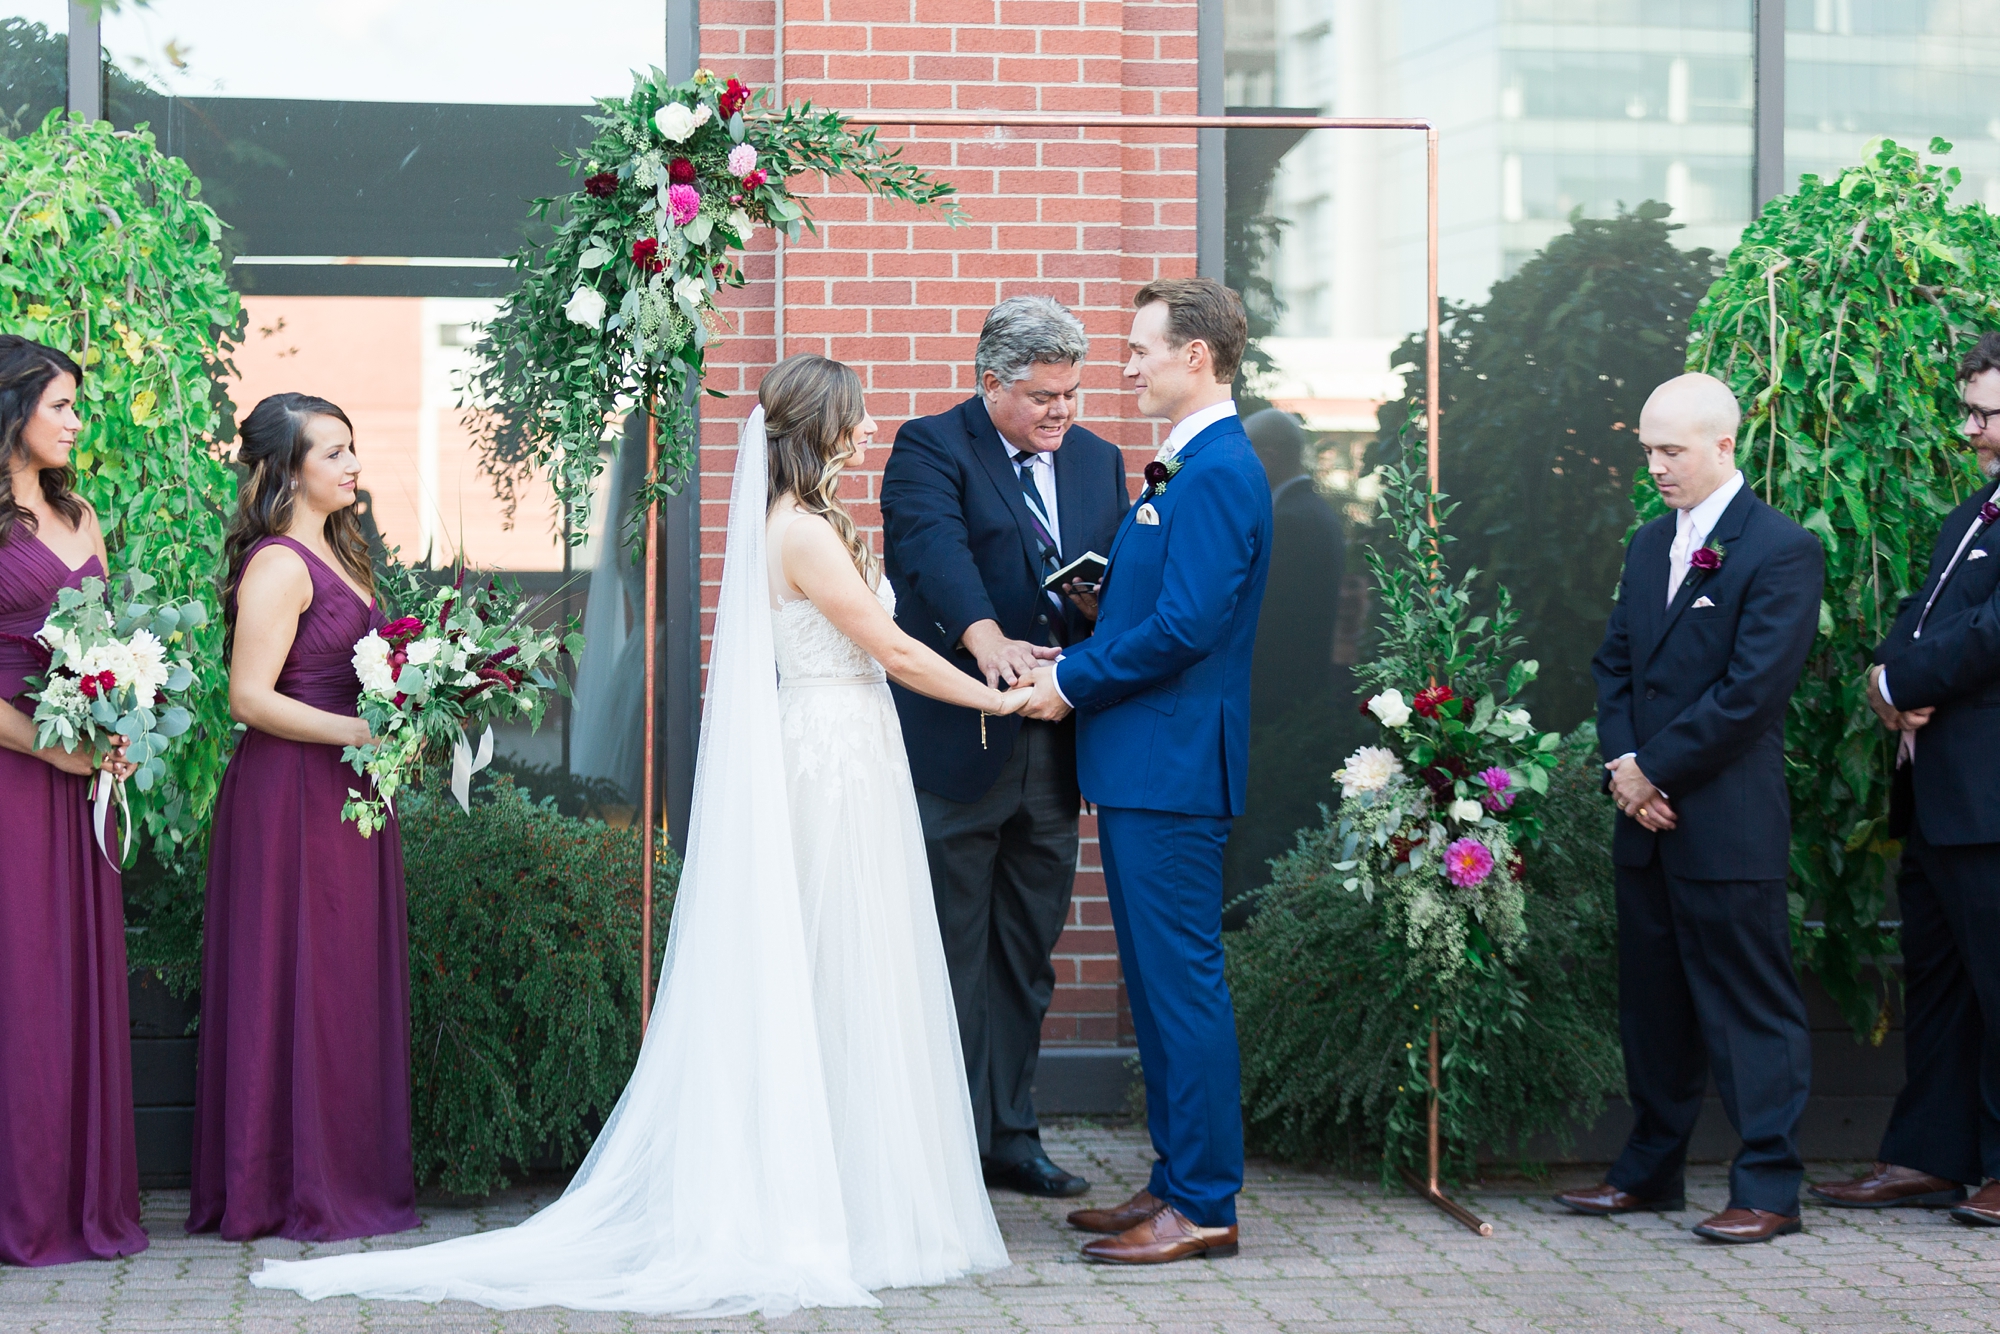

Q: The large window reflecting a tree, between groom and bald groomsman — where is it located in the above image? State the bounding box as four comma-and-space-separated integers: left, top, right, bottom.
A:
1224, 0, 1754, 920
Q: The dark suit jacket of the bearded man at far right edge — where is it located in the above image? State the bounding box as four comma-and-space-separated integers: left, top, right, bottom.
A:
1874, 486, 2000, 846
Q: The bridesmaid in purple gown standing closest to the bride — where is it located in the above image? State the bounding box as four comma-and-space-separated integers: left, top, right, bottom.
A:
188, 394, 418, 1242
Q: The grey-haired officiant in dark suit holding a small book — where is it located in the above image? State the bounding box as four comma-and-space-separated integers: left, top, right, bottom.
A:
882, 296, 1130, 1196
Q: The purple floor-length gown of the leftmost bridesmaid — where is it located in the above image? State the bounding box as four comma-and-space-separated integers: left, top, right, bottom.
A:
0, 522, 146, 1264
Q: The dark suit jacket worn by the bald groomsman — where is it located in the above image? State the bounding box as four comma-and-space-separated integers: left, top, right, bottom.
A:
1590, 486, 1826, 880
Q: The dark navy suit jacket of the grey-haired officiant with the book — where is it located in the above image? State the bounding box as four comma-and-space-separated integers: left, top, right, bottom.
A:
882, 398, 1132, 802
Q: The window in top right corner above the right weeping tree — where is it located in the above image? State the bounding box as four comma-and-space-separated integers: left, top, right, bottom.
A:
1784, 0, 2000, 208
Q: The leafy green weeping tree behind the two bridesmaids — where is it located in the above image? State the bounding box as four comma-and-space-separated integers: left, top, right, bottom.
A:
0, 112, 242, 858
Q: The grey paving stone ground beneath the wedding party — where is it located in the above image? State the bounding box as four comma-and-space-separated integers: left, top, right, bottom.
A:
0, 1122, 2000, 1334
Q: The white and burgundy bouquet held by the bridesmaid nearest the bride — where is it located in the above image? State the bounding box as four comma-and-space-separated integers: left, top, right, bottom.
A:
340, 568, 584, 838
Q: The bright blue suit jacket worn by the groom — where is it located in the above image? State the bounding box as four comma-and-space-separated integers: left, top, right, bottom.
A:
1056, 416, 1270, 816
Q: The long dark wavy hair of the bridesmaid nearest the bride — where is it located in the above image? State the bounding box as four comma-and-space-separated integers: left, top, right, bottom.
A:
222, 394, 374, 656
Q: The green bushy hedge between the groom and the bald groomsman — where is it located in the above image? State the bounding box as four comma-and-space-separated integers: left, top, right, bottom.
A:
1228, 724, 1624, 1178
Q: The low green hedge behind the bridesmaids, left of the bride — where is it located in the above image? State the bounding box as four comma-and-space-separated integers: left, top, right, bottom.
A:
126, 774, 680, 1196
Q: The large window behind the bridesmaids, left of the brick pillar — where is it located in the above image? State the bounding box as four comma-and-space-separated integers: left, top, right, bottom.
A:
102, 0, 666, 816
